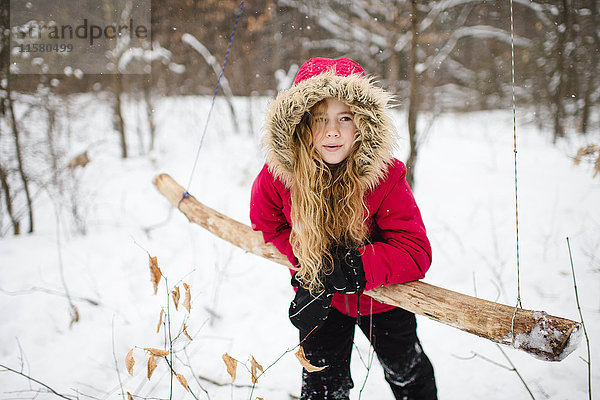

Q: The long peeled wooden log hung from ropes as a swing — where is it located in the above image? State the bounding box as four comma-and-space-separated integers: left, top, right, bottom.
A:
153, 174, 581, 361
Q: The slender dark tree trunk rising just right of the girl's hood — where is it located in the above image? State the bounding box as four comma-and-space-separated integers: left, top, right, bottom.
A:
406, 0, 419, 190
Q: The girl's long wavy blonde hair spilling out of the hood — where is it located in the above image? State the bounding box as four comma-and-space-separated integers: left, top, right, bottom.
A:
290, 101, 368, 293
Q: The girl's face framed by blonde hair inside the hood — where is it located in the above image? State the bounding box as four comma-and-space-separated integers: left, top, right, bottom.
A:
310, 97, 356, 165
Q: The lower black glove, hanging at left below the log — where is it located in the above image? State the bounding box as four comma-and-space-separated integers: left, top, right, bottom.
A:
289, 275, 334, 334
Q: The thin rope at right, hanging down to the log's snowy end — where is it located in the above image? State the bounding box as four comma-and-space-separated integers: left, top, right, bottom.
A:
510, 0, 522, 342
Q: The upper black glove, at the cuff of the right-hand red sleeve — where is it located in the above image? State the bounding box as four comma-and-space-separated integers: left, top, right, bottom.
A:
325, 247, 366, 294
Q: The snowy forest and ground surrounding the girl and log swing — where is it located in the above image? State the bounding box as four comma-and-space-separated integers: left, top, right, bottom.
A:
0, 0, 600, 400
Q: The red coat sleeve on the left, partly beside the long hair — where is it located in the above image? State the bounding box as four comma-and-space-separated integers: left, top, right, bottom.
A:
250, 165, 298, 265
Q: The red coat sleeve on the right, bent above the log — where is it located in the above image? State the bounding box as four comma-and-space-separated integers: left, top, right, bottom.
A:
361, 161, 431, 290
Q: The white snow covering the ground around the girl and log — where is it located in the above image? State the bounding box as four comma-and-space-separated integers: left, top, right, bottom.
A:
0, 97, 600, 400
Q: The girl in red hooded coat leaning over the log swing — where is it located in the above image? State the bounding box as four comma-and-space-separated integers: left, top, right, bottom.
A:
250, 58, 437, 400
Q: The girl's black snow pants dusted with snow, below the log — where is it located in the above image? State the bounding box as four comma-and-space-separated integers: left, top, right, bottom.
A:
300, 308, 437, 400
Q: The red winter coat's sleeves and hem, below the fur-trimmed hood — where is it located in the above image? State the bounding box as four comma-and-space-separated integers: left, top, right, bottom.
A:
250, 159, 431, 316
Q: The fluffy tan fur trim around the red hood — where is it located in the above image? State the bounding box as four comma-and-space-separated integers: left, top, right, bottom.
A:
263, 72, 397, 189
